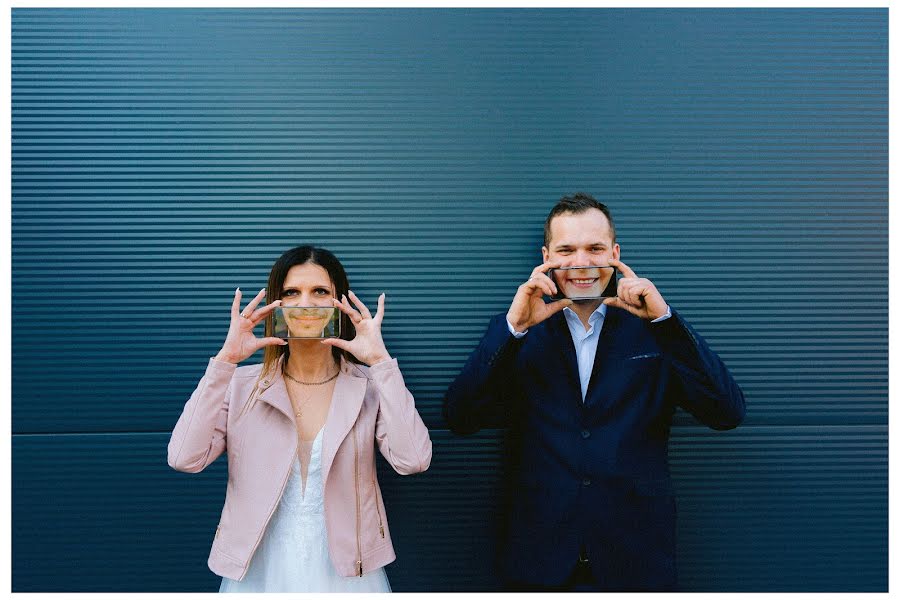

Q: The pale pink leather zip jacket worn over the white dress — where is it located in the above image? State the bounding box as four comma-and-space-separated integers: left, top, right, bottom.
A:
169, 359, 431, 580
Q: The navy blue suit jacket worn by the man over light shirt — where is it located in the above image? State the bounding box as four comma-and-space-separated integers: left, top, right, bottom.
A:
444, 307, 744, 590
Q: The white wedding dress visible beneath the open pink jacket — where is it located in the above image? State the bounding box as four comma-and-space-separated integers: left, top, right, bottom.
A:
219, 427, 391, 592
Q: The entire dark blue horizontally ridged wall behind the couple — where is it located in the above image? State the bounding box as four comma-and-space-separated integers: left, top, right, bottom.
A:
12, 8, 888, 592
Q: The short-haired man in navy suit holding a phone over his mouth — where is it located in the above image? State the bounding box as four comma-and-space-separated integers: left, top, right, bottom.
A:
444, 194, 744, 591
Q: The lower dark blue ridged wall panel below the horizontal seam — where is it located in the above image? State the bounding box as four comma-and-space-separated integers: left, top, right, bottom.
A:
12, 426, 888, 592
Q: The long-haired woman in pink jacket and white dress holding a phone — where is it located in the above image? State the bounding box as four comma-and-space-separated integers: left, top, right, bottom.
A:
169, 246, 431, 592
